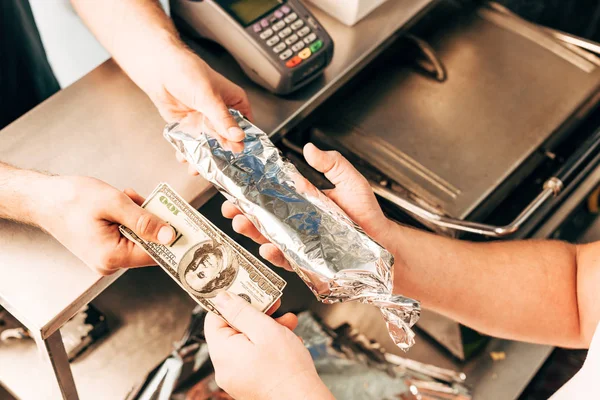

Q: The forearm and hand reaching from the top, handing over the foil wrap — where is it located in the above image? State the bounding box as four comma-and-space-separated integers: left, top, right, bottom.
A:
71, 0, 252, 148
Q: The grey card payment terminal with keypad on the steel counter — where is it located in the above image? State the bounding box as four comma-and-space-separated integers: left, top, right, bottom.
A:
172, 0, 333, 94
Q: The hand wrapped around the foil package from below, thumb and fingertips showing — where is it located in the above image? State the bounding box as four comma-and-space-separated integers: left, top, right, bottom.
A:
221, 143, 391, 270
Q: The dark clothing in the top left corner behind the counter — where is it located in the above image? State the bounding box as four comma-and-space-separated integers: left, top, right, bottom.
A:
0, 0, 60, 129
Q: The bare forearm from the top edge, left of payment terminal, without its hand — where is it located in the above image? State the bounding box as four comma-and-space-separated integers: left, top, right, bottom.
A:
71, 0, 187, 97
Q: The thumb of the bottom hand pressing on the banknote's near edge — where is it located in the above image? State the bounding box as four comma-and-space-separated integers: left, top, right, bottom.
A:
213, 292, 275, 343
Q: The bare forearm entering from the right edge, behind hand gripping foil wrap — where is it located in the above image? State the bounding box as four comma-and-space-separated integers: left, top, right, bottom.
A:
387, 220, 586, 347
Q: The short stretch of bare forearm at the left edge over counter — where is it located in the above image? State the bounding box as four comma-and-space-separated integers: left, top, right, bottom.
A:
0, 162, 48, 226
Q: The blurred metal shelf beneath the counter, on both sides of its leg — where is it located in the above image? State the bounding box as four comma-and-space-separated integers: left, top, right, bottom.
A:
0, 267, 196, 400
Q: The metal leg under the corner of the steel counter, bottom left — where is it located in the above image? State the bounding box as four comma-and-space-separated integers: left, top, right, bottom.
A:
35, 330, 79, 400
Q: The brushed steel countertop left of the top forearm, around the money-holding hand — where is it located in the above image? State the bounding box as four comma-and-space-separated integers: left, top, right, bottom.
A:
0, 61, 211, 338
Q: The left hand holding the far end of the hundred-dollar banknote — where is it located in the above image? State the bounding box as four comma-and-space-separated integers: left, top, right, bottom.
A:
35, 176, 175, 275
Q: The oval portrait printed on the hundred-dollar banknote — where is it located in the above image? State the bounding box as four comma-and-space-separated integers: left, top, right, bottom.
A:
178, 240, 239, 297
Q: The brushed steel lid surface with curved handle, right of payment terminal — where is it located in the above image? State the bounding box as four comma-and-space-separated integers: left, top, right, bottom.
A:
318, 10, 600, 219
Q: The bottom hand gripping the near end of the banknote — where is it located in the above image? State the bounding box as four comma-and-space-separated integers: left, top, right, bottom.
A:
204, 292, 333, 400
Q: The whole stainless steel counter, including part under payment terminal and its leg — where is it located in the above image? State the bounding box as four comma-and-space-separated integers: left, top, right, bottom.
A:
0, 0, 433, 398
